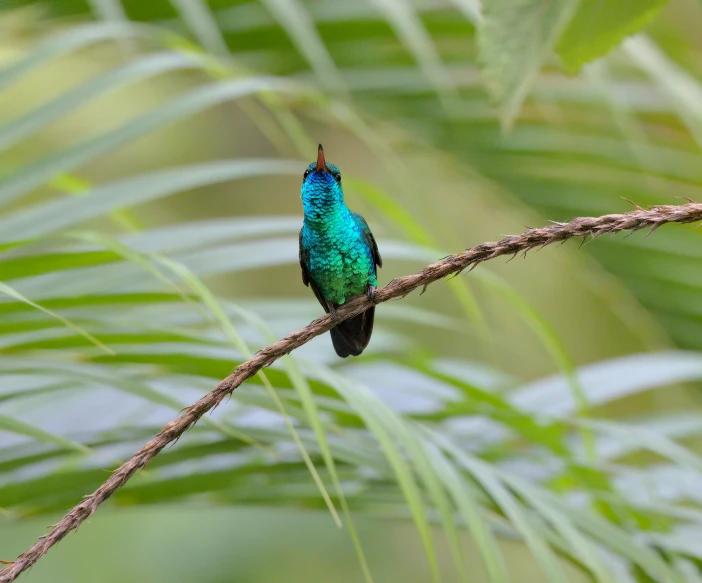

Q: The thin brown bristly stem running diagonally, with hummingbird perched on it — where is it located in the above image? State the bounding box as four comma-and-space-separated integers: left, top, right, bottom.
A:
0, 201, 702, 583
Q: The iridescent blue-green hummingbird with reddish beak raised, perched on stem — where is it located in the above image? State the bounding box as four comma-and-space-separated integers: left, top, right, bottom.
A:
300, 144, 383, 358
